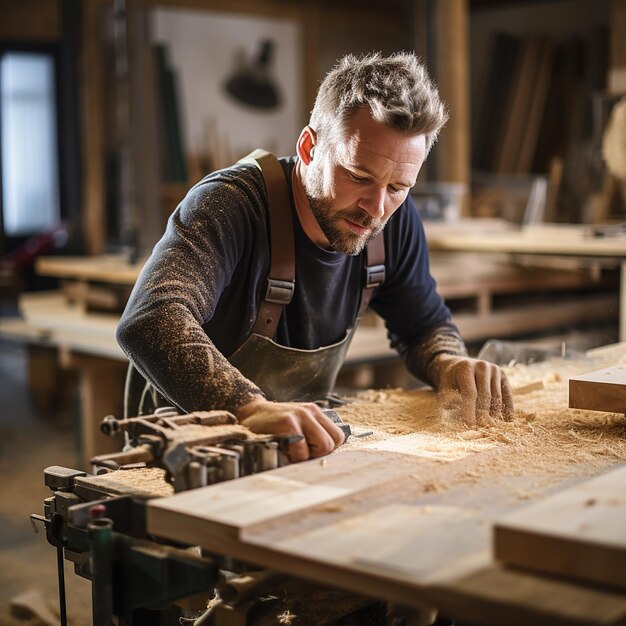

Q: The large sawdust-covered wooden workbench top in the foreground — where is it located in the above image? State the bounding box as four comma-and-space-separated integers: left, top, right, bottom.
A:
147, 344, 626, 626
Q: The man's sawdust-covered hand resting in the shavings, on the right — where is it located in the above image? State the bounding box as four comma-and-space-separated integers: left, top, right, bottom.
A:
434, 355, 513, 426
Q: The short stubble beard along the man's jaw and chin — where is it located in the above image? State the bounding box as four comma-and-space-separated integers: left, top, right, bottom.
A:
304, 166, 385, 256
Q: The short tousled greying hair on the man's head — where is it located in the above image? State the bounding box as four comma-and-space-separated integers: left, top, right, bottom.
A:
310, 52, 448, 154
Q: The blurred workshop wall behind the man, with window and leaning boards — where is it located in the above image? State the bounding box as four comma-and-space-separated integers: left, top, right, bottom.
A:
0, 0, 626, 266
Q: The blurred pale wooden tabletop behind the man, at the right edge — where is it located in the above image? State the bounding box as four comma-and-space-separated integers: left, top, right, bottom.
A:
426, 219, 626, 340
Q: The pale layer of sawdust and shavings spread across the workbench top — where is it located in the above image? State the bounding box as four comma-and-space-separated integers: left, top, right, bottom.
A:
337, 355, 626, 488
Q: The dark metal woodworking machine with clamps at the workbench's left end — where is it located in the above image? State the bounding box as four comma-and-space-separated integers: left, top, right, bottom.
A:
31, 405, 390, 626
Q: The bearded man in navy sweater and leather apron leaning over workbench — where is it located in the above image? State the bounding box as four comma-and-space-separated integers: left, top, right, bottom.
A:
117, 53, 513, 461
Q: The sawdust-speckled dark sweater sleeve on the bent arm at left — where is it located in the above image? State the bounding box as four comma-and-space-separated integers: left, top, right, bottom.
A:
117, 166, 264, 411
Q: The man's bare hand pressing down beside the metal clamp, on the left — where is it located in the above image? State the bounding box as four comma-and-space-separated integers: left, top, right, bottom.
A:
237, 398, 345, 463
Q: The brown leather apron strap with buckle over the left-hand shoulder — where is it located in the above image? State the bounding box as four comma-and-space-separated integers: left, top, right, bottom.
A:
239, 150, 296, 339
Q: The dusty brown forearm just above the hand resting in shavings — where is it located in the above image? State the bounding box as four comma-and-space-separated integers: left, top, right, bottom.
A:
403, 323, 467, 389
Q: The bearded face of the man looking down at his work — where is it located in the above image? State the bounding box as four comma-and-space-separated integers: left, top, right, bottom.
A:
304, 108, 426, 255
